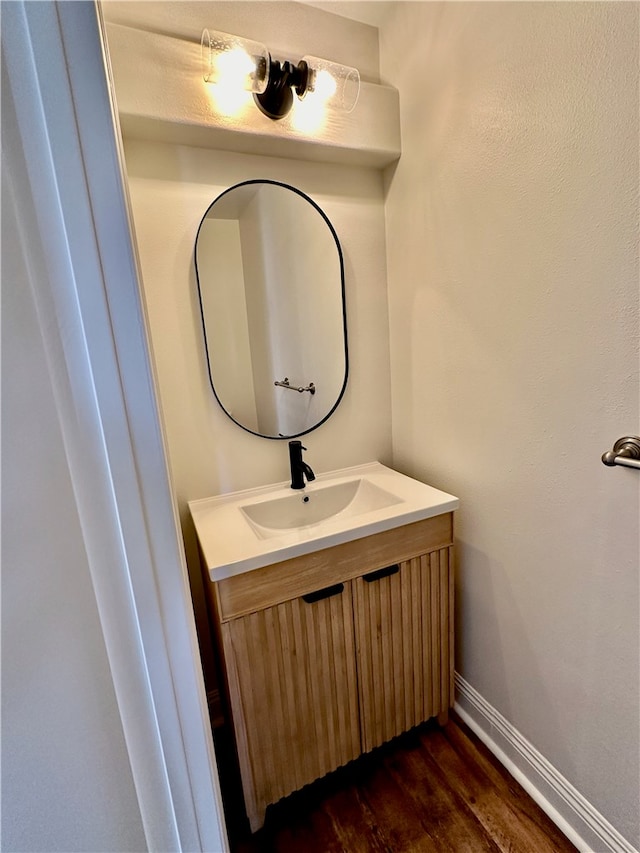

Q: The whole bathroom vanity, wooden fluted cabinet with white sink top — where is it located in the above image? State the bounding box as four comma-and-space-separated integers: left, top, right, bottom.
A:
190, 463, 458, 831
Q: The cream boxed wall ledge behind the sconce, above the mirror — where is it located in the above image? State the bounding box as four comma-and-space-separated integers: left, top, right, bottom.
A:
106, 23, 400, 169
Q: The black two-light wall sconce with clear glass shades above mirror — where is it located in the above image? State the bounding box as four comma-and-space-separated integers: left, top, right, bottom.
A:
202, 30, 360, 119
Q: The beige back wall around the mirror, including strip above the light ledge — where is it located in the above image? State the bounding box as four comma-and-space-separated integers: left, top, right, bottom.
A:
104, 2, 391, 704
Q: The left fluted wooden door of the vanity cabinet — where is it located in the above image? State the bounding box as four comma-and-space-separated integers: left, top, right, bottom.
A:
221, 584, 361, 830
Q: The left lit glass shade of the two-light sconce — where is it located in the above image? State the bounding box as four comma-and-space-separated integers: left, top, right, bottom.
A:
201, 30, 270, 94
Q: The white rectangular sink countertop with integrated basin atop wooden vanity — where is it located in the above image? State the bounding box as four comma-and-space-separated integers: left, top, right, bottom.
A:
189, 462, 459, 581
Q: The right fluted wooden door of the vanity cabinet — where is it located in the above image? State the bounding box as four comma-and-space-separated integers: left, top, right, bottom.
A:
353, 548, 453, 752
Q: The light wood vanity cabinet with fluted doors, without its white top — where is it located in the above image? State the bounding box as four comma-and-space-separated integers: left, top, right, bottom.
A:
206, 513, 453, 832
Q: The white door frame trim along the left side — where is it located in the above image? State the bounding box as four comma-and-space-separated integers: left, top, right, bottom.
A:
2, 0, 228, 853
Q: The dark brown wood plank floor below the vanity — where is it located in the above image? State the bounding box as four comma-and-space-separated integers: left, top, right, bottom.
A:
218, 719, 576, 853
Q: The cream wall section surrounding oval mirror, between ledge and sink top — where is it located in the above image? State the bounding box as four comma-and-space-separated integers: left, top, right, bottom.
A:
126, 140, 391, 500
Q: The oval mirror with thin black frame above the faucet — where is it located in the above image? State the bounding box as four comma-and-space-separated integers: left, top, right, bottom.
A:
195, 180, 348, 438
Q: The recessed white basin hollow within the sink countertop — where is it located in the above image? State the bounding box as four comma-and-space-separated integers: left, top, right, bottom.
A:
240, 477, 401, 539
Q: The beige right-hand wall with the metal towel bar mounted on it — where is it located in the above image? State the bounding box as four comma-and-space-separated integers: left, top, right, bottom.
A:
380, 3, 640, 845
